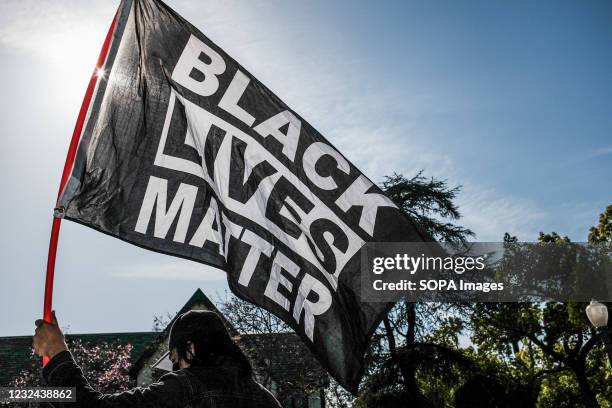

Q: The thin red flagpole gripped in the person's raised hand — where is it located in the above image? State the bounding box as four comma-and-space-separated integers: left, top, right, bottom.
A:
43, 10, 119, 366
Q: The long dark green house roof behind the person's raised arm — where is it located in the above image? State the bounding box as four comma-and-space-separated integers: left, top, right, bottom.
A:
0, 332, 159, 386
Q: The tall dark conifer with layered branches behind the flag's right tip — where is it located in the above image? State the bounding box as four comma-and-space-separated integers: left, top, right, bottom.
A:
357, 171, 474, 407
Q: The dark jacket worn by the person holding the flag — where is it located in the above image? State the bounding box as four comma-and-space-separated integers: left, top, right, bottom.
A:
43, 351, 280, 408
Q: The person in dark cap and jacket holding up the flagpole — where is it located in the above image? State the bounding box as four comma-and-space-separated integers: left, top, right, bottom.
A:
33, 310, 280, 408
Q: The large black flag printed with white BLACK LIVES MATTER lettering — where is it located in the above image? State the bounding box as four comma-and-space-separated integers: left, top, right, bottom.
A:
58, 0, 427, 392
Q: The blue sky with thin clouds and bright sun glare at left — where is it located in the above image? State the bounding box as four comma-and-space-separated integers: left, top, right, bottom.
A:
0, 0, 612, 336
